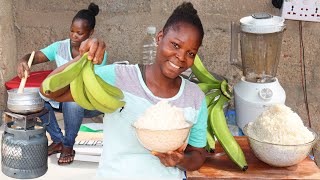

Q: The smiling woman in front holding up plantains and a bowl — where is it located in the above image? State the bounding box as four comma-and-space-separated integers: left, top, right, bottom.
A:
41, 3, 208, 180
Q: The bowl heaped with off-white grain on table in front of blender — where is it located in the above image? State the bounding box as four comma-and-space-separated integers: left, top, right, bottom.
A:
243, 104, 318, 167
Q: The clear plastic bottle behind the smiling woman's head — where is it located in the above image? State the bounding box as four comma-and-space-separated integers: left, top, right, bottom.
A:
142, 26, 157, 64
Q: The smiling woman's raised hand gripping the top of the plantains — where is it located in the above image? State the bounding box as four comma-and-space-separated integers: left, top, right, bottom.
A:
79, 38, 107, 64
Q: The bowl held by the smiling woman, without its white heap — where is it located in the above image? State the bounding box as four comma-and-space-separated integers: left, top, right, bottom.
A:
133, 124, 192, 153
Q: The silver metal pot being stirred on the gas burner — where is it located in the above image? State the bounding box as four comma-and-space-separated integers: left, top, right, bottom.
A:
7, 88, 44, 114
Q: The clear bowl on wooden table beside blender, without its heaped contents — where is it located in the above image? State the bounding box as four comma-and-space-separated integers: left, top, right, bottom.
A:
243, 125, 318, 167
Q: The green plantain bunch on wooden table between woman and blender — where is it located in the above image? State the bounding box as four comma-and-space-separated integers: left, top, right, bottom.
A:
191, 55, 248, 171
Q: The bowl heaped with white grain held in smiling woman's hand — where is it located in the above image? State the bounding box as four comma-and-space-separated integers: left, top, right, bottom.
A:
132, 101, 192, 153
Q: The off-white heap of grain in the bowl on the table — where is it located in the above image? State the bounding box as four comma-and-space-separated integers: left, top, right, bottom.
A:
247, 104, 314, 145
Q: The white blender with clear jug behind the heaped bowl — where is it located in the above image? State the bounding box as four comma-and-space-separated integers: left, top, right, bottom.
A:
231, 13, 286, 129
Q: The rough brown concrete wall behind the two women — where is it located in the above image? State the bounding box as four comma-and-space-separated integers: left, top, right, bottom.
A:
0, 0, 320, 162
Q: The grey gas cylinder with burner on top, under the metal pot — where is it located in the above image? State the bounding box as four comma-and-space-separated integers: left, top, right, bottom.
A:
1, 108, 48, 179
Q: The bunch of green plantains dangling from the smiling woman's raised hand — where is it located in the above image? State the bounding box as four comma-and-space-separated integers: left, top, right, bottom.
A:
42, 53, 125, 113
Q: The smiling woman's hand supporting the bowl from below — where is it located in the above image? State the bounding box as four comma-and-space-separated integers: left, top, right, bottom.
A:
151, 144, 187, 167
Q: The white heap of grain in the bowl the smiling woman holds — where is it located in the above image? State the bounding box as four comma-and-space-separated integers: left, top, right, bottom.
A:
134, 101, 190, 130
